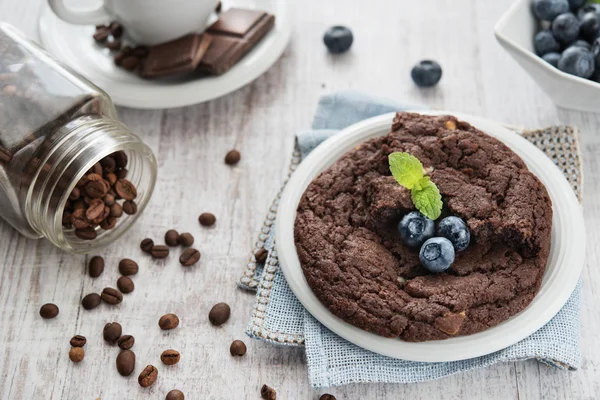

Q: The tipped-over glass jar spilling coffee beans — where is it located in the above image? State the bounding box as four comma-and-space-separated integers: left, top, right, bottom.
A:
0, 23, 157, 253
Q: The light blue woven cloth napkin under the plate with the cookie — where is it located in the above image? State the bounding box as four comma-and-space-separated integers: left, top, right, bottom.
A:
243, 92, 581, 388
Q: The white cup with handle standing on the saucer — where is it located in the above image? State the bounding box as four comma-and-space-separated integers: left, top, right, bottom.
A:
48, 0, 218, 45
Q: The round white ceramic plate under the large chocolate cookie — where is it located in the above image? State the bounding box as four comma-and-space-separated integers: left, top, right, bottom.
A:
276, 111, 585, 362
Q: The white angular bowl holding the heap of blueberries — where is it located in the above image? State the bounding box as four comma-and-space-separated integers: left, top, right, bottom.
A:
494, 0, 600, 112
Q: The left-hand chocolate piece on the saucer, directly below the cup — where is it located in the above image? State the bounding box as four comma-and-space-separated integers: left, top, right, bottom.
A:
139, 33, 213, 78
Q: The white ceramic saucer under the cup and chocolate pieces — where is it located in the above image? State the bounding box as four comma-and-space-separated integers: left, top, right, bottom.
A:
40, 0, 292, 108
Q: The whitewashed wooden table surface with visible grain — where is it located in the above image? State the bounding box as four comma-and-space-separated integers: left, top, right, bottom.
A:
0, 0, 600, 400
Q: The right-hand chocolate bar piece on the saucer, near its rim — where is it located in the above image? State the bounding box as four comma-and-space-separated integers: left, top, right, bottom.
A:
198, 8, 275, 75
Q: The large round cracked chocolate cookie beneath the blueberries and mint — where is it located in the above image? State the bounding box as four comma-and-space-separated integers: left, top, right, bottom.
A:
294, 113, 552, 342
